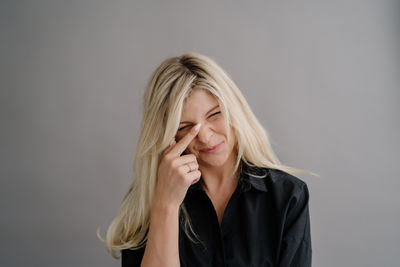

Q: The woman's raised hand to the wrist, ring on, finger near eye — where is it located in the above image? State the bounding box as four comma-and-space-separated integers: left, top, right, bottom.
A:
153, 124, 201, 208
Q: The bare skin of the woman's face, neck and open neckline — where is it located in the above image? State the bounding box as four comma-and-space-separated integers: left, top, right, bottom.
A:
176, 88, 239, 224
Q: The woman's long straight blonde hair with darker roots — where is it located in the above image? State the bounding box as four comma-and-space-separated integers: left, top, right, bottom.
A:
97, 53, 316, 258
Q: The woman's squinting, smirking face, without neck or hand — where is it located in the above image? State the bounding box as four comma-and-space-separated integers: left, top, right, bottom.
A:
175, 88, 236, 167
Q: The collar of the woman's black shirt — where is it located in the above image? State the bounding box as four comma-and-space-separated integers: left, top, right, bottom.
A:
189, 161, 269, 192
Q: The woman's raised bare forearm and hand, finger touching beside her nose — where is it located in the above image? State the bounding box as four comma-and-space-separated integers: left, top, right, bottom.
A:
141, 124, 201, 267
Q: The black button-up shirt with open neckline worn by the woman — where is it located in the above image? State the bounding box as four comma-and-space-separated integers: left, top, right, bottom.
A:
121, 162, 312, 267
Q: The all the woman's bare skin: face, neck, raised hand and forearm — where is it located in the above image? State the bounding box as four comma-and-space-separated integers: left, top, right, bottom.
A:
141, 89, 238, 266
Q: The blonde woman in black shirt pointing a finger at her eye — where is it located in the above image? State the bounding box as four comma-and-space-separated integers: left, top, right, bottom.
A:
100, 53, 312, 267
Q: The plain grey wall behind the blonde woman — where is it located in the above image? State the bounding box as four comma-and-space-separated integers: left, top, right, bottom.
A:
0, 0, 400, 267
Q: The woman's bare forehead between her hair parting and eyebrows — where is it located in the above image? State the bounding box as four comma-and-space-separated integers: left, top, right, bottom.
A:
182, 88, 218, 113
